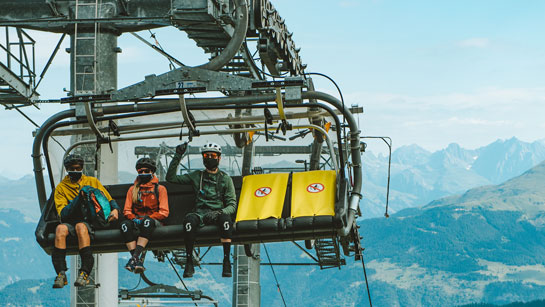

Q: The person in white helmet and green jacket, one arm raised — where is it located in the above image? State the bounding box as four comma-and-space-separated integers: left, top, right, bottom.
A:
166, 142, 237, 278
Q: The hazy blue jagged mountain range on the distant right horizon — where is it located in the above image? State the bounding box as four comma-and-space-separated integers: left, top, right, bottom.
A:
361, 137, 545, 218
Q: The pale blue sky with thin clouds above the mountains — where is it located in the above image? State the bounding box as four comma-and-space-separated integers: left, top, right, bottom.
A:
0, 0, 545, 178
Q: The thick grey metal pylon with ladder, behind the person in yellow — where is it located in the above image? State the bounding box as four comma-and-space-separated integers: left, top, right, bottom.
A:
70, 1, 121, 307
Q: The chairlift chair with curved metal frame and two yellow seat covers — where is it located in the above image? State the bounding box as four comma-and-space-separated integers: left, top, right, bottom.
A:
33, 86, 361, 270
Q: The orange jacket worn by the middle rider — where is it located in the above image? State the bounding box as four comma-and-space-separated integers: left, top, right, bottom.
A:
123, 176, 169, 221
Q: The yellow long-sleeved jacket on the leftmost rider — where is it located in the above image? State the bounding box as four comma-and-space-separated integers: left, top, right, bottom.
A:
54, 175, 112, 216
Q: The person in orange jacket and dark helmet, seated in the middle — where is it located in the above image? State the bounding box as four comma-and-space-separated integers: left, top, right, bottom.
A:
121, 158, 169, 273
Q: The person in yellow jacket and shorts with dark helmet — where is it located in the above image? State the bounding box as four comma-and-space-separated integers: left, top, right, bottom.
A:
51, 154, 119, 288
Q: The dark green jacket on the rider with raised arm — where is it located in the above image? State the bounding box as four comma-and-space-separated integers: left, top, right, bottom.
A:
166, 153, 237, 217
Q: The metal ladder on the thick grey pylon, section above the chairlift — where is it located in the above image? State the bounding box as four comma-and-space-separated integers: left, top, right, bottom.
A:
73, 0, 99, 96
